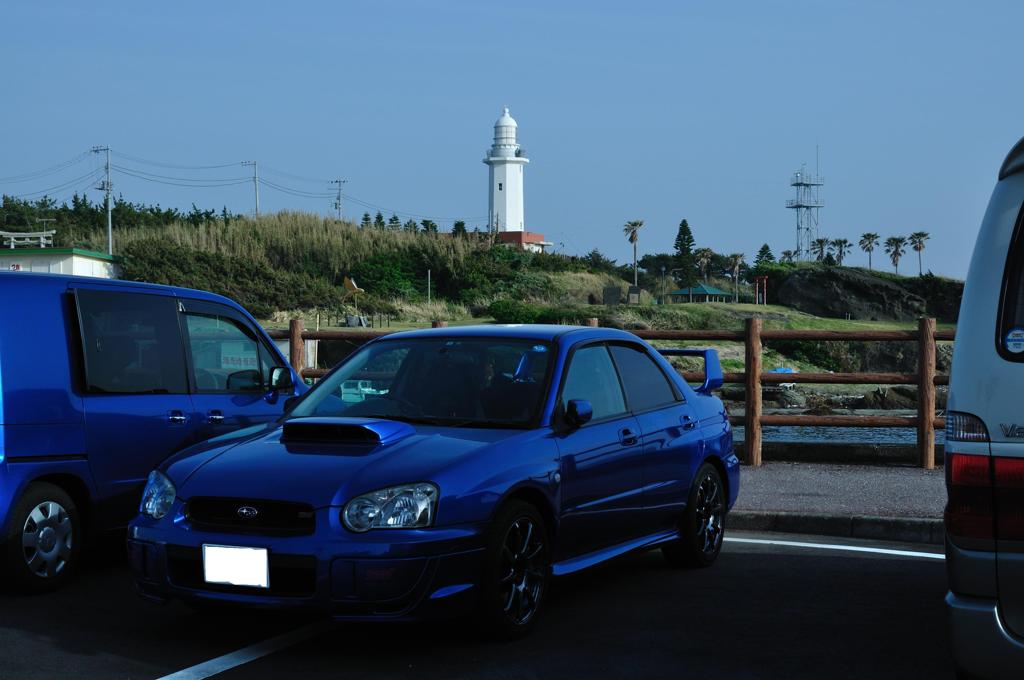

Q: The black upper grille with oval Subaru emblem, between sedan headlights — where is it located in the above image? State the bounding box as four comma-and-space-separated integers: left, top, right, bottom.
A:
185, 496, 316, 536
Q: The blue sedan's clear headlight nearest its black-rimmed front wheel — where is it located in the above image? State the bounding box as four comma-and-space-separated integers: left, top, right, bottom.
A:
341, 482, 437, 533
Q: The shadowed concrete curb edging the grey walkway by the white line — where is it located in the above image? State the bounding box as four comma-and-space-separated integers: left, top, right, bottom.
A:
726, 510, 945, 545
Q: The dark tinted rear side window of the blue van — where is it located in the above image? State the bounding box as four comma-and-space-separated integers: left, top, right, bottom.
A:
77, 290, 188, 394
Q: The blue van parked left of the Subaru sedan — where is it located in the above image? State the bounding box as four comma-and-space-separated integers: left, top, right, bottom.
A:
0, 272, 305, 591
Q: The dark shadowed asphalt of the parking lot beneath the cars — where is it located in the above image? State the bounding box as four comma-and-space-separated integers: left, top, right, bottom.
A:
0, 533, 953, 680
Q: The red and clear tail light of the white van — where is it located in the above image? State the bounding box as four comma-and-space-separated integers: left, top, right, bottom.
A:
945, 412, 1024, 542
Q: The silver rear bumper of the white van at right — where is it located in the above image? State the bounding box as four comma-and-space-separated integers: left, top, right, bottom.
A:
946, 593, 1024, 678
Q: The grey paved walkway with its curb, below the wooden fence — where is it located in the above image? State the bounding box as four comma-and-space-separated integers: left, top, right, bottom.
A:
729, 463, 946, 544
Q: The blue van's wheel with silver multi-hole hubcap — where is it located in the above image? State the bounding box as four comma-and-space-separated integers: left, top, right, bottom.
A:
4, 482, 82, 593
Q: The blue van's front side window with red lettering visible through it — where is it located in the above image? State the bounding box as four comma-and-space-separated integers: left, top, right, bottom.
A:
185, 314, 272, 392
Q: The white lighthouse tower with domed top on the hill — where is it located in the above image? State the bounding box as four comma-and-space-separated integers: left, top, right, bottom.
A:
483, 107, 529, 232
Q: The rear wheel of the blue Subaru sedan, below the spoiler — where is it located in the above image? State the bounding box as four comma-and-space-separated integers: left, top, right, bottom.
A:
662, 463, 726, 568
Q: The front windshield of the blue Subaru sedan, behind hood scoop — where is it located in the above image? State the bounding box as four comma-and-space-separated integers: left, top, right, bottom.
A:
289, 338, 551, 427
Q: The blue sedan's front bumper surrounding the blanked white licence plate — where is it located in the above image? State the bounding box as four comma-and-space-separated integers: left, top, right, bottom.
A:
128, 518, 484, 620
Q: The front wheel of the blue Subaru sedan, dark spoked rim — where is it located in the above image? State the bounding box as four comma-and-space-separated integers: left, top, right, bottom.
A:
477, 501, 551, 640
